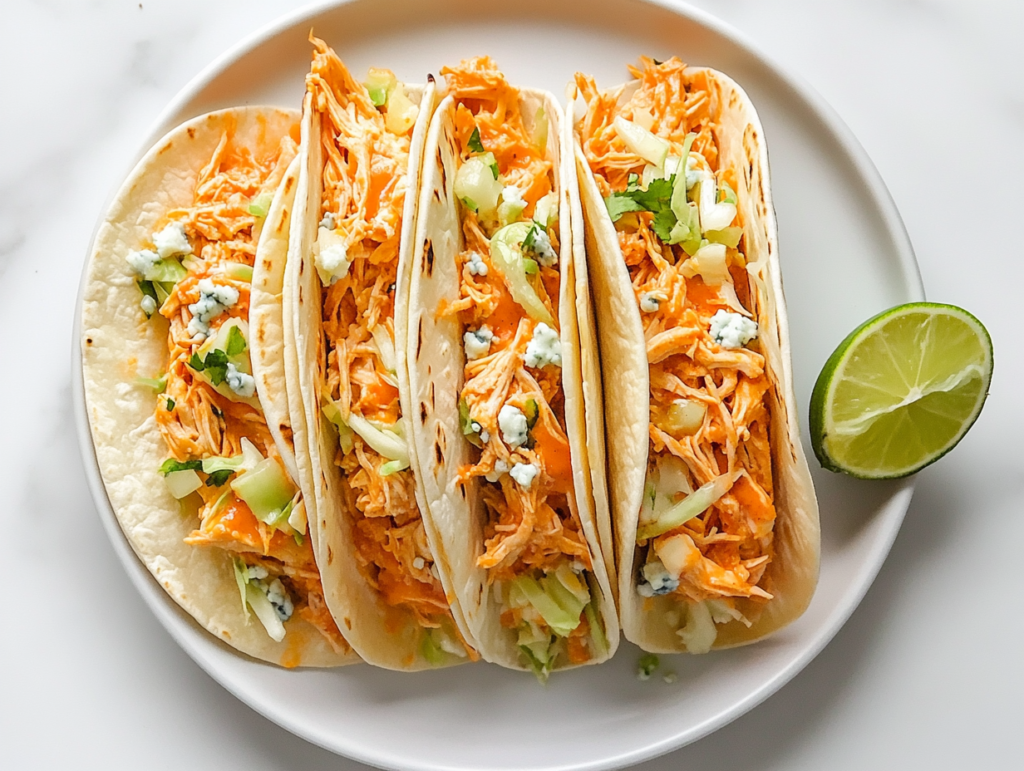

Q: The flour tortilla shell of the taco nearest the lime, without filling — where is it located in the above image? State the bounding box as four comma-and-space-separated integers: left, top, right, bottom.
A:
573, 70, 820, 653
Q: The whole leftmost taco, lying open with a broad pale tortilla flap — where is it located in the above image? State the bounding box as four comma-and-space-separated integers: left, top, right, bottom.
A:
82, 108, 357, 667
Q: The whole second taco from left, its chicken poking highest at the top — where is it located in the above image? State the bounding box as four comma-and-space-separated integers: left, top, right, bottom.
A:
286, 38, 476, 670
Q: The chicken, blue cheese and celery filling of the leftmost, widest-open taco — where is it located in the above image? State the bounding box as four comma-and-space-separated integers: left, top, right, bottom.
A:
127, 115, 349, 653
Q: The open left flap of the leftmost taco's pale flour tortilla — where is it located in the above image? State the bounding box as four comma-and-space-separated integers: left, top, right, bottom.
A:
81, 106, 357, 667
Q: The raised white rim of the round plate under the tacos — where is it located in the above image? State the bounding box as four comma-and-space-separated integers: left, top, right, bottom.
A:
71, 0, 926, 771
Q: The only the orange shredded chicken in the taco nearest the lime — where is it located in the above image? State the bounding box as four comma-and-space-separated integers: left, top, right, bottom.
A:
575, 58, 775, 617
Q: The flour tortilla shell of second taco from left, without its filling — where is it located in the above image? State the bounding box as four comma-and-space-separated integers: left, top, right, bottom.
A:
285, 81, 468, 671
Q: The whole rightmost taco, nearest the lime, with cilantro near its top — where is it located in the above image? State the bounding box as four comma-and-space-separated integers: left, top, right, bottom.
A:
574, 58, 819, 653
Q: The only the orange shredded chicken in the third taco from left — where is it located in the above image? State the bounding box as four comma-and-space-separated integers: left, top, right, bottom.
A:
440, 56, 593, 651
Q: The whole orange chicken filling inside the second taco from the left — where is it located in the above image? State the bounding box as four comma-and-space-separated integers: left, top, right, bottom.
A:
306, 39, 467, 662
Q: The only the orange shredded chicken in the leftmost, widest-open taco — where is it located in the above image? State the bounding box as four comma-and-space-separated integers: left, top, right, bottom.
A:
147, 115, 350, 653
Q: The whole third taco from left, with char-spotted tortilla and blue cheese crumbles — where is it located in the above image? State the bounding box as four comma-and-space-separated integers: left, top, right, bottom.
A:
406, 57, 618, 678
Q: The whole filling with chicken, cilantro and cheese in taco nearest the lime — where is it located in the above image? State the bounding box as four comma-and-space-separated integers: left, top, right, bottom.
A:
575, 58, 775, 652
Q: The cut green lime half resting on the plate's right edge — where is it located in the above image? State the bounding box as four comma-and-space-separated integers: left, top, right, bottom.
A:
810, 302, 992, 479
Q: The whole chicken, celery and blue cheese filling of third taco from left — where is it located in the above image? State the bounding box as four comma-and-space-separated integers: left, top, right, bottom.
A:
439, 57, 608, 676
